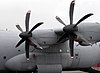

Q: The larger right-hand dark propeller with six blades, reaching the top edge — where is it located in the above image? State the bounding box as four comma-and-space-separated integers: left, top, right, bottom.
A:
56, 0, 93, 58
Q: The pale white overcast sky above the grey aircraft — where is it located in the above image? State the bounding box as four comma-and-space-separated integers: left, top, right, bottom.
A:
0, 0, 100, 30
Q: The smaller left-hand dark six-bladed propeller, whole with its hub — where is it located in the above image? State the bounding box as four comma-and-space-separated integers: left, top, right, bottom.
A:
16, 10, 43, 60
